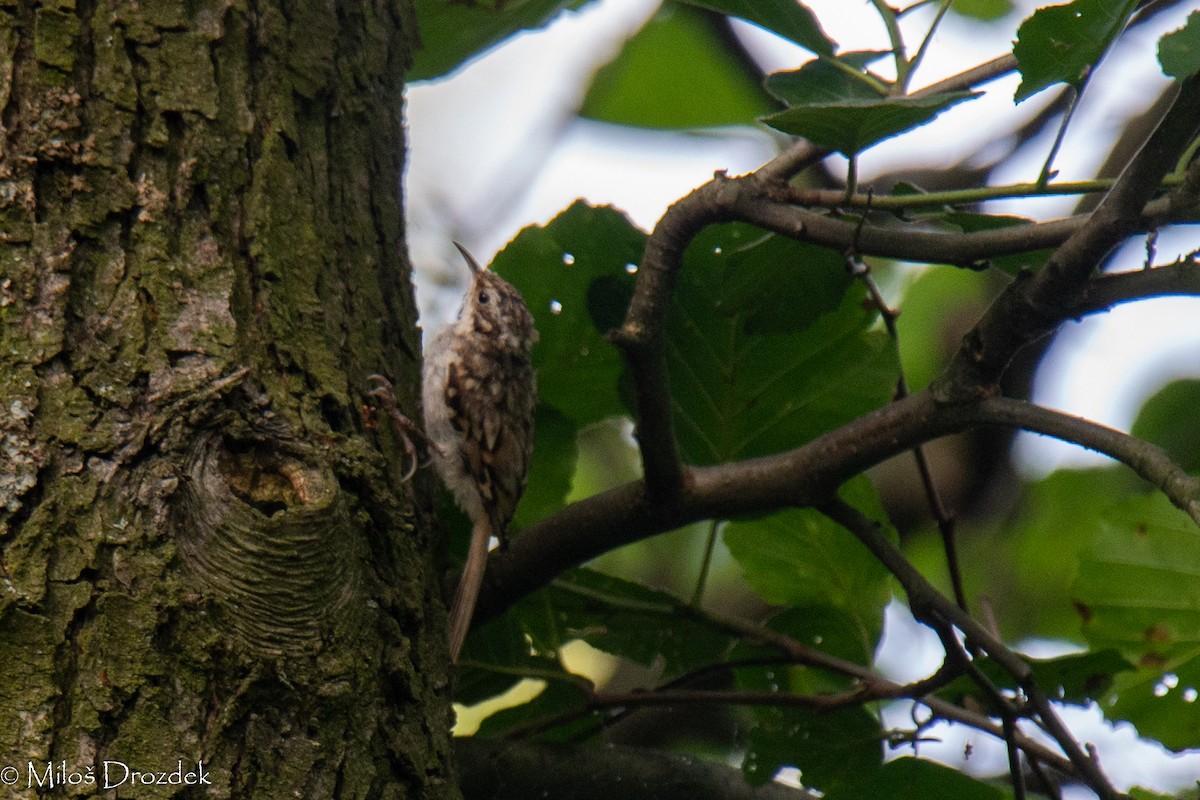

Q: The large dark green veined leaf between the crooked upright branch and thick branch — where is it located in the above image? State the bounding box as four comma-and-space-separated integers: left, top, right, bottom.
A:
667, 224, 896, 464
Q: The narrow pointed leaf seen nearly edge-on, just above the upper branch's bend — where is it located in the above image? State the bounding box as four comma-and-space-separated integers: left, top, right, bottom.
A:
762, 91, 979, 156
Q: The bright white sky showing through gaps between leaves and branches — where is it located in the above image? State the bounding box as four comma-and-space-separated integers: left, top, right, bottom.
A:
407, 0, 1200, 789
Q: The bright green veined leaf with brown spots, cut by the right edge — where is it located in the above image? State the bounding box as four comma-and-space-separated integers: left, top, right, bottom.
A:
1074, 494, 1200, 664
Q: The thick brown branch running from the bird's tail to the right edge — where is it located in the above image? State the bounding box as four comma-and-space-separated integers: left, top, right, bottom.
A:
476, 388, 1200, 620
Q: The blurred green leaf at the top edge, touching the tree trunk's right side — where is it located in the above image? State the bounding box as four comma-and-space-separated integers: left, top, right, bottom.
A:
407, 0, 587, 80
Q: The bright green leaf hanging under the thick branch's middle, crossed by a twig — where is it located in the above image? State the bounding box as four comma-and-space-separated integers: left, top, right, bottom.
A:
725, 476, 892, 654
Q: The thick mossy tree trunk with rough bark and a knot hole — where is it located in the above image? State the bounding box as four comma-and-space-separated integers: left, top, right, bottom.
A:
0, 0, 456, 798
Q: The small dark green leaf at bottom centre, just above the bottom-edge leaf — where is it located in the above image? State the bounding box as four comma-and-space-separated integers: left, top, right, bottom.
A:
742, 706, 887, 796
